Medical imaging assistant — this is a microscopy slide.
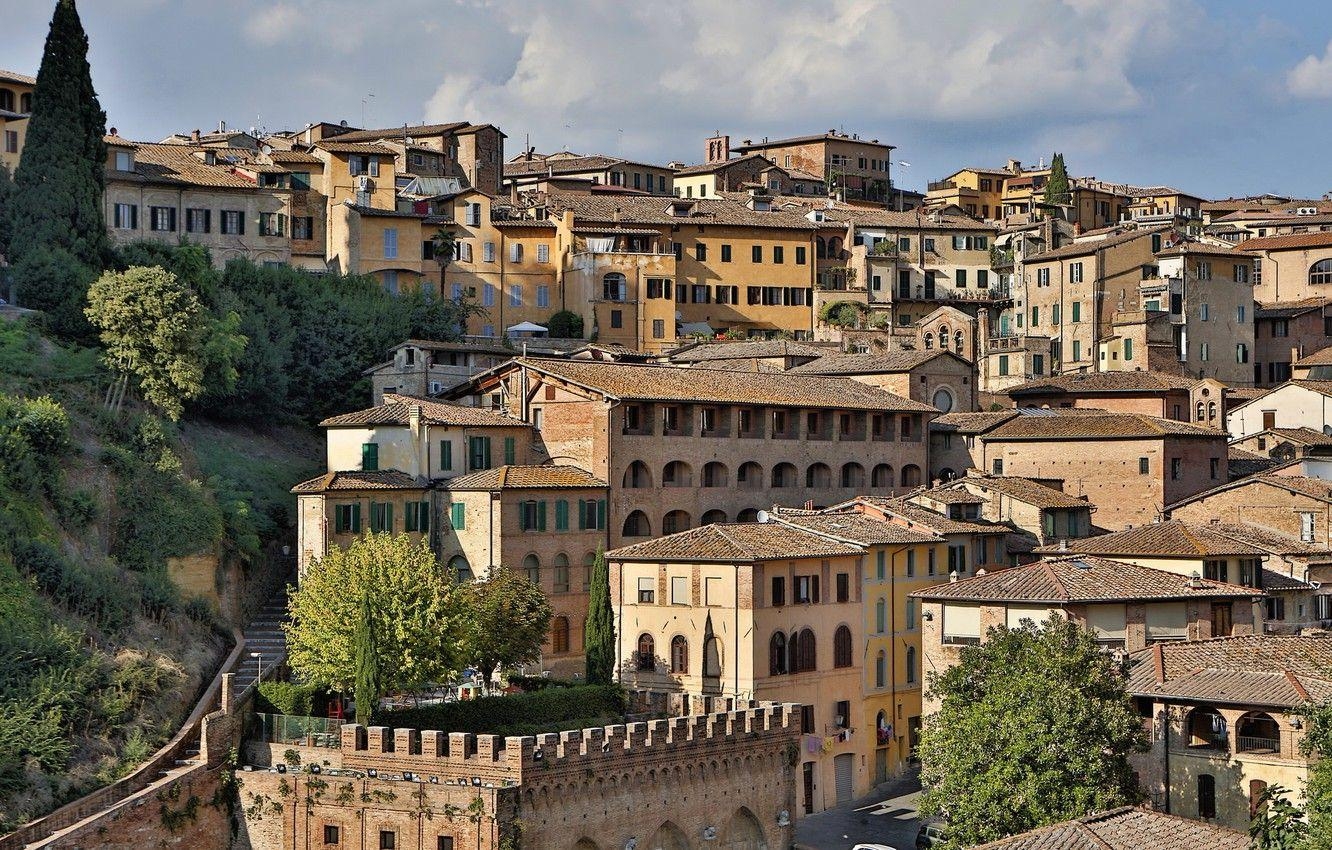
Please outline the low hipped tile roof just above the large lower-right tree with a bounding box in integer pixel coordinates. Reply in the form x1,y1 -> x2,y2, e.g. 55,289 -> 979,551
910,556 -> 1263,605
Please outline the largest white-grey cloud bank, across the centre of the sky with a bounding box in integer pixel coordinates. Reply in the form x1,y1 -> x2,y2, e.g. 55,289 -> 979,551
426,0 -> 1197,161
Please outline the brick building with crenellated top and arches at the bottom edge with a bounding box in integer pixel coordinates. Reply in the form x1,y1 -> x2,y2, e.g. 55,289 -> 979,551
236,702 -> 799,850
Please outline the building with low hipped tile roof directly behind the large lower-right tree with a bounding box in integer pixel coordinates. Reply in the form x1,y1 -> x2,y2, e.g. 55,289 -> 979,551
911,556 -> 1261,714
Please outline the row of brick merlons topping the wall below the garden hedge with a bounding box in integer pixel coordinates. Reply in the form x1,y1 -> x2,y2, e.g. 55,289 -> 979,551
341,699 -> 799,787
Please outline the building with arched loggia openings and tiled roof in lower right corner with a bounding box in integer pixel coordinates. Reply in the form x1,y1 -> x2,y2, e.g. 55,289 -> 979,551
1128,636 -> 1332,830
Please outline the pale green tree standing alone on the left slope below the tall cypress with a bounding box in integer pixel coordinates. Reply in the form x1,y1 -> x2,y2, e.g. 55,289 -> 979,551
84,266 -> 209,420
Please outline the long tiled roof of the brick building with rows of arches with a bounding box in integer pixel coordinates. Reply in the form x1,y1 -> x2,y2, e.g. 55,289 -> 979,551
496,358 -> 934,413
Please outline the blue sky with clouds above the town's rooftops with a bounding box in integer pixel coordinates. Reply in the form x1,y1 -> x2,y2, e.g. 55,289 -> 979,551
0,0 -> 1332,197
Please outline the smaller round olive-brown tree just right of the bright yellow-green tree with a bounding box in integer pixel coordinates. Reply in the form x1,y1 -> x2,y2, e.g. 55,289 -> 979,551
462,568 -> 551,687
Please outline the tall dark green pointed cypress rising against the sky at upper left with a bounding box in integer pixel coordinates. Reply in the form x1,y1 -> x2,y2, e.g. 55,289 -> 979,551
4,0 -> 107,336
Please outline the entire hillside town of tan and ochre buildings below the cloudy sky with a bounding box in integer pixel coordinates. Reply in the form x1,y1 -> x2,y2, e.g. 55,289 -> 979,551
0,0 -> 1332,850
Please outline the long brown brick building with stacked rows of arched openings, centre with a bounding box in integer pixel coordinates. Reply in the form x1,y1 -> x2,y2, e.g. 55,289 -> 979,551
452,358 -> 934,545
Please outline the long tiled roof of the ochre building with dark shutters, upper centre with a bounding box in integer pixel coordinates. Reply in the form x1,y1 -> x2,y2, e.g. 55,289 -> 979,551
550,192 -> 814,230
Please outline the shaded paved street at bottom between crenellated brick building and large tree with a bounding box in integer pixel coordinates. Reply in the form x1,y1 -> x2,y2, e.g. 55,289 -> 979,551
795,778 -> 920,850
